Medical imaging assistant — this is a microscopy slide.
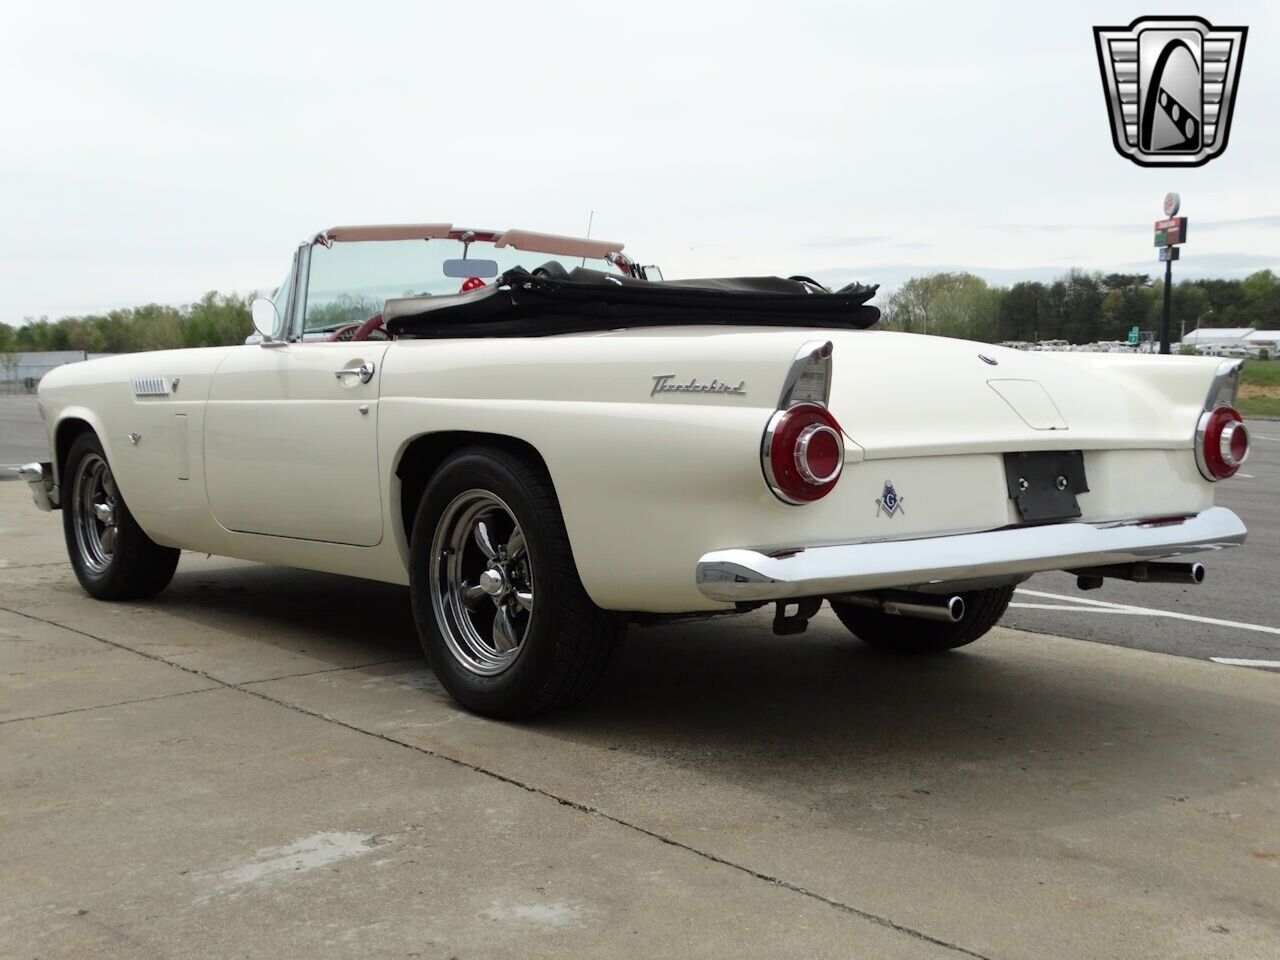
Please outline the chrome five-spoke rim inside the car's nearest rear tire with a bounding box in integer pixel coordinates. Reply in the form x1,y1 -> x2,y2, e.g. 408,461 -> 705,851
430,490 -> 534,677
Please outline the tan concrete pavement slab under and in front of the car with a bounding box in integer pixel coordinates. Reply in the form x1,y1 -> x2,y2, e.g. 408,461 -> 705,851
0,484 -> 1280,960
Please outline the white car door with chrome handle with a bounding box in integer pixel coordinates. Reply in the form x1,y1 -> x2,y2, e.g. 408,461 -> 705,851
205,340 -> 390,547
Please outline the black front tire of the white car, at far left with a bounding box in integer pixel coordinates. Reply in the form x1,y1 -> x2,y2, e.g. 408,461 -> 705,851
60,433 -> 182,600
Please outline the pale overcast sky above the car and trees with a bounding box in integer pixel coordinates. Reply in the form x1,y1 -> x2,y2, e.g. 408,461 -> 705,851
0,0 -> 1280,323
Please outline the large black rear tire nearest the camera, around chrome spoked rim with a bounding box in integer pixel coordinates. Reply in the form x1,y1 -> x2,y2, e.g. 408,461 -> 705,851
410,447 -> 626,719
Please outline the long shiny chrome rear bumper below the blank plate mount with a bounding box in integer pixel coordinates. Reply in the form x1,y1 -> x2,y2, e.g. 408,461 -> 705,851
696,507 -> 1245,602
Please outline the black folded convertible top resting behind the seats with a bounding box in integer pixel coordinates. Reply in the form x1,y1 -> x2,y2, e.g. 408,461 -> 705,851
383,268 -> 879,338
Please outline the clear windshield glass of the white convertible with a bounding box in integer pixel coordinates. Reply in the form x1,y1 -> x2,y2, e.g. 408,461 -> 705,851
303,239 -> 621,333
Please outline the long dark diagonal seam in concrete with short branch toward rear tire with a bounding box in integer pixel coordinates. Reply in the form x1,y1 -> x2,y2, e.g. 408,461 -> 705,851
0,607 -> 993,960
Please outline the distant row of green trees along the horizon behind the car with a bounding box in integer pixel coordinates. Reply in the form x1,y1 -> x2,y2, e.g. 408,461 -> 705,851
0,270 -> 1280,353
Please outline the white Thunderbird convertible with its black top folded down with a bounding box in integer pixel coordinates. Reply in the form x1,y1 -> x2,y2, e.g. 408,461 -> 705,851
22,224 -> 1248,717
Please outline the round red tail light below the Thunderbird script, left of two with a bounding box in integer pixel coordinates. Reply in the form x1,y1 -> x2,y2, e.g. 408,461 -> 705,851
760,403 -> 845,503
